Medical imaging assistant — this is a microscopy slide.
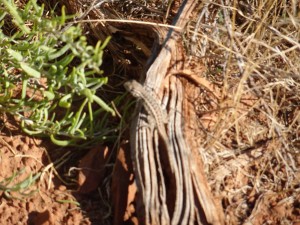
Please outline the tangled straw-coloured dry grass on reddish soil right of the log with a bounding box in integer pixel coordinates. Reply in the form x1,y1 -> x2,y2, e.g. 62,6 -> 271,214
186,1 -> 300,224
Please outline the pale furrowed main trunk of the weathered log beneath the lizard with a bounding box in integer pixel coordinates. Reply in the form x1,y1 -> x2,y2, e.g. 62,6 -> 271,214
131,0 -> 224,225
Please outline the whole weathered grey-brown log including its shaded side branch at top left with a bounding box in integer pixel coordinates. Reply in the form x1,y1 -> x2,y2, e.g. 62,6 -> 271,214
58,0 -> 225,225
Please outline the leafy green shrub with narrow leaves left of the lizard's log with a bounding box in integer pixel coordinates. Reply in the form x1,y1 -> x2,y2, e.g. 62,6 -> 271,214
0,0 -> 115,146
